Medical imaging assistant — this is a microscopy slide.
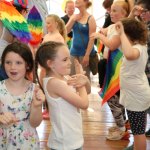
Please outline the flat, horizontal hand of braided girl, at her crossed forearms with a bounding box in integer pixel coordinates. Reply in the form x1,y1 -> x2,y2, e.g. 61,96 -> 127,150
67,74 -> 89,88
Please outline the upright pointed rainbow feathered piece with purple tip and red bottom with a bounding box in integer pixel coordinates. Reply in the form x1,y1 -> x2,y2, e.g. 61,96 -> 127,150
27,6 -> 43,45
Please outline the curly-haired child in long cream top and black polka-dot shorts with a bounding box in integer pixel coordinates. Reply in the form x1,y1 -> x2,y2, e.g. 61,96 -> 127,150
116,19 -> 150,150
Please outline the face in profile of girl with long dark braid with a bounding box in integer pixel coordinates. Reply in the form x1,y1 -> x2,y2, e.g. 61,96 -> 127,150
52,46 -> 71,75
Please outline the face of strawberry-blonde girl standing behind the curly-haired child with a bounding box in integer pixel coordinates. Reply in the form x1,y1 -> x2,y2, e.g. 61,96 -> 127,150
110,4 -> 126,23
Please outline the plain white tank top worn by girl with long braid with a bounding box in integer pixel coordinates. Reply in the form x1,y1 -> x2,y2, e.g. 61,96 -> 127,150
43,77 -> 83,150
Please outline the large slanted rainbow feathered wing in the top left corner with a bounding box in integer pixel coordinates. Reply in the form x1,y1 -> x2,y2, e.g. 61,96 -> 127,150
0,1 -> 31,43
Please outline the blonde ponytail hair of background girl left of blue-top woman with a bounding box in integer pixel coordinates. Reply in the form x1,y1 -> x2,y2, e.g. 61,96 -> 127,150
47,14 -> 67,41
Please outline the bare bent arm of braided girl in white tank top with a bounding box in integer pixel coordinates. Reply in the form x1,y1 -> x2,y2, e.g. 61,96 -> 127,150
47,78 -> 89,109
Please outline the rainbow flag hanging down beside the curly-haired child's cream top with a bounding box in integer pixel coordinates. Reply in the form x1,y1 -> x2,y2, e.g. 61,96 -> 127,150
99,49 -> 123,105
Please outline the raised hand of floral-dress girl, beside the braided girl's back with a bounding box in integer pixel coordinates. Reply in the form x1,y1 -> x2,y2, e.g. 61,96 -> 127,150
33,87 -> 45,107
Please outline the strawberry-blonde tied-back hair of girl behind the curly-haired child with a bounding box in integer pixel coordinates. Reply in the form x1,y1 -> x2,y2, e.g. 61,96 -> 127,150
113,0 -> 130,17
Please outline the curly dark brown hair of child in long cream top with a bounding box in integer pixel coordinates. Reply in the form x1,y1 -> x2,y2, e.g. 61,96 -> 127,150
121,18 -> 148,45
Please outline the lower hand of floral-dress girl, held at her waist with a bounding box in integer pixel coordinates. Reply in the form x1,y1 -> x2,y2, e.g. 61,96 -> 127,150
0,112 -> 18,125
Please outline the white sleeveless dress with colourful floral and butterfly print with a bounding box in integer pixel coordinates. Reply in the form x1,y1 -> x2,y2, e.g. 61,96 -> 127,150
0,80 -> 40,150
